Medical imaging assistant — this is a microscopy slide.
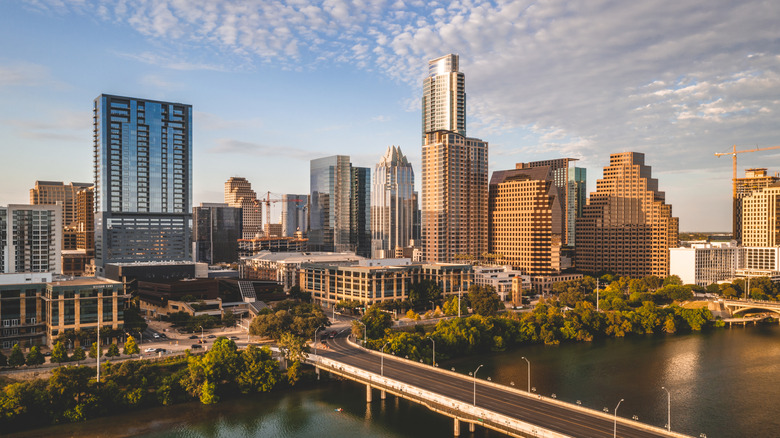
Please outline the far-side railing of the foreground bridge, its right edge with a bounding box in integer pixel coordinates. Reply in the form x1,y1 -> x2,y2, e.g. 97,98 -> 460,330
347,338 -> 690,438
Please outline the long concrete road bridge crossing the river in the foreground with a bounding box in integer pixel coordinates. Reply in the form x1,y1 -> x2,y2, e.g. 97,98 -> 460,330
306,336 -> 688,438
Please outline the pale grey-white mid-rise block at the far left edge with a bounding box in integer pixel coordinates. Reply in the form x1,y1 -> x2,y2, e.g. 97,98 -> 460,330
0,204 -> 62,274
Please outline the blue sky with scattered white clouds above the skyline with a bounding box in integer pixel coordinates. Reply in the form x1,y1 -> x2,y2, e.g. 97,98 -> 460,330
0,0 -> 780,231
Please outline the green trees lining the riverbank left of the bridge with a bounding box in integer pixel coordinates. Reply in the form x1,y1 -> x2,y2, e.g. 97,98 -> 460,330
0,337 -> 300,431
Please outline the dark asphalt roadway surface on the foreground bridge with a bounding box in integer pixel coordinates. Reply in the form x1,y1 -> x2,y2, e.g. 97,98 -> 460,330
319,337 -> 684,438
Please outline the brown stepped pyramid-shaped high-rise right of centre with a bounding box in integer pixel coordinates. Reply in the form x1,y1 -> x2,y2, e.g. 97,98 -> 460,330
576,152 -> 678,278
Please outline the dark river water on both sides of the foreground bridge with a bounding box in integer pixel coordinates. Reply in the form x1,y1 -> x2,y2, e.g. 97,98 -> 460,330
10,325 -> 780,438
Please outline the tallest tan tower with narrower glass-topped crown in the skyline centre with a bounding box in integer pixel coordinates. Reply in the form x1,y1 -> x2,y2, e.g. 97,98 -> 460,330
420,55 -> 488,262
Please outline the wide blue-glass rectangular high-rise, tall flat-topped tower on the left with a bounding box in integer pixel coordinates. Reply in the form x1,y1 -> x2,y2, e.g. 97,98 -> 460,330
93,94 -> 192,270
